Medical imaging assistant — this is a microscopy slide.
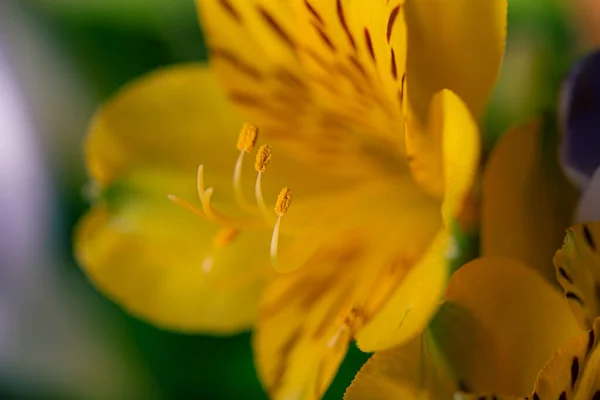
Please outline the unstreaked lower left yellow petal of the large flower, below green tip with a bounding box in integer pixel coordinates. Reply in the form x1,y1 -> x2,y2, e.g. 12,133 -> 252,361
75,170 -> 270,333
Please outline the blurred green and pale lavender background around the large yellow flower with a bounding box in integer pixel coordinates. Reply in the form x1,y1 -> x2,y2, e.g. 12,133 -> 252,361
0,0 -> 600,399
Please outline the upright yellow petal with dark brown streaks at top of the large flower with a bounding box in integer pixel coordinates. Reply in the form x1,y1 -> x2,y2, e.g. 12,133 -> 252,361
196,0 -> 406,158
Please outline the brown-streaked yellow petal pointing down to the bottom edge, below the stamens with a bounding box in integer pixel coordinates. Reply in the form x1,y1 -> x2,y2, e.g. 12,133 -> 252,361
254,180 -> 443,398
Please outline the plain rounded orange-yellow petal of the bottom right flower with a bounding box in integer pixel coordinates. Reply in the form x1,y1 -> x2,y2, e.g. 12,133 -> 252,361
446,257 -> 580,396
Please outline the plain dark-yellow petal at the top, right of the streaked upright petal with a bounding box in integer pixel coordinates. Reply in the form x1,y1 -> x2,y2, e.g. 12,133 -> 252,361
404,0 -> 507,121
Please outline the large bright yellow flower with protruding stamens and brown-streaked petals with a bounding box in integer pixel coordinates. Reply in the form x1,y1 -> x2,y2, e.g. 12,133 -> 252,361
76,0 -> 506,399
